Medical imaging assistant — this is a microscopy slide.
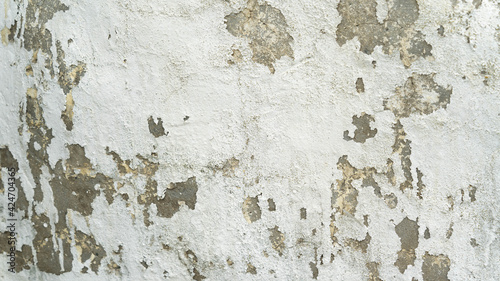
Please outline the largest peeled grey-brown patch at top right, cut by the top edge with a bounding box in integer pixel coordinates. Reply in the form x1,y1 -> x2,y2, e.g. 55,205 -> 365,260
337,0 -> 432,68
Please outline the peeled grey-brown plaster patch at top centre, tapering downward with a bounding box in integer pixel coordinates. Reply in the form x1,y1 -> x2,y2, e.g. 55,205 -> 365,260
225,0 -> 293,73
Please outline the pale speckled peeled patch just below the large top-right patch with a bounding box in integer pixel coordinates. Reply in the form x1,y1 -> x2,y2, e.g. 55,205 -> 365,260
383,73 -> 452,118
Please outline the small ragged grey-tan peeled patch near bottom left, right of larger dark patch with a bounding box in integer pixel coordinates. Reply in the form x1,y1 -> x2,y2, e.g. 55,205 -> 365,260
75,230 -> 106,274
